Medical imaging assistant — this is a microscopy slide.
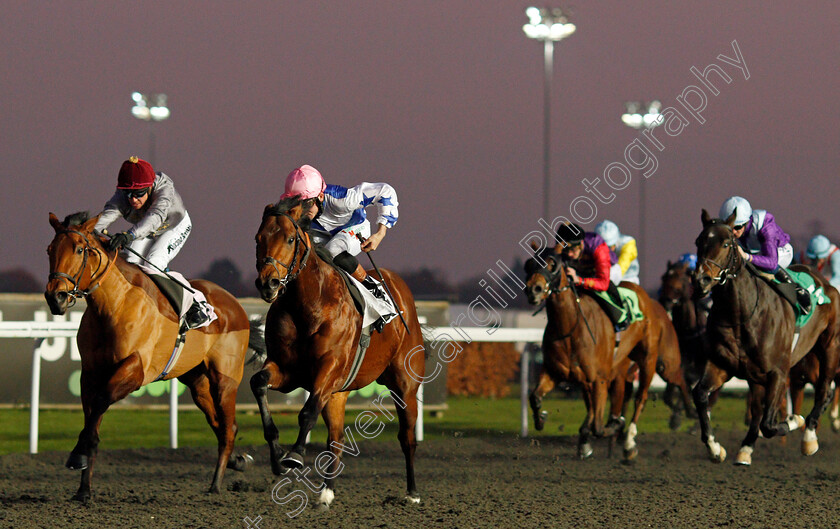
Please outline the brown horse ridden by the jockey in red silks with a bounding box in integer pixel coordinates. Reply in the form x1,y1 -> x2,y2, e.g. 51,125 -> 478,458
525,253 -> 676,459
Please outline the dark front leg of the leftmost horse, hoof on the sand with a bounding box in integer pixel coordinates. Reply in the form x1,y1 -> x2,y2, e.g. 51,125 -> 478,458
65,354 -> 143,502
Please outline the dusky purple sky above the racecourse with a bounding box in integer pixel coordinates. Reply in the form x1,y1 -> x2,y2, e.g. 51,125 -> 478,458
6,0 -> 840,286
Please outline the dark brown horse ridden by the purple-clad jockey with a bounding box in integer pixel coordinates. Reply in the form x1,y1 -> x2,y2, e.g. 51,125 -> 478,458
693,209 -> 840,465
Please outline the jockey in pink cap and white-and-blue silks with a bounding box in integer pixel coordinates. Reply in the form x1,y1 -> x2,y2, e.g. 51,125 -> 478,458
280,165 -> 399,324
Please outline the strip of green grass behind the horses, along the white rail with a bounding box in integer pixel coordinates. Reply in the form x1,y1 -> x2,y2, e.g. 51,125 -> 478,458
0,392 -> 746,455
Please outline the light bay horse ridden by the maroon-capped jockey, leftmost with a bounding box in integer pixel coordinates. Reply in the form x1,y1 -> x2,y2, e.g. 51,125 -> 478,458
44,209 -> 262,501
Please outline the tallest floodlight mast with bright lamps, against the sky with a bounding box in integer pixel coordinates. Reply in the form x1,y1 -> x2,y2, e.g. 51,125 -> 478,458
522,7 -> 576,222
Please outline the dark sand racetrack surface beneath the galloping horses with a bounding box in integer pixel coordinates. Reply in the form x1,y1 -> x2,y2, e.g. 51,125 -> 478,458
0,428 -> 840,529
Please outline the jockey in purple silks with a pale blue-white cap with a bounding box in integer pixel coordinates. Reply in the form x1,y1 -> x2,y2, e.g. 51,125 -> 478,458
720,196 -> 811,313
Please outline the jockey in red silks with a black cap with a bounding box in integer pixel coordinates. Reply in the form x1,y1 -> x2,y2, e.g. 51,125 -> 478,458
554,223 -> 630,331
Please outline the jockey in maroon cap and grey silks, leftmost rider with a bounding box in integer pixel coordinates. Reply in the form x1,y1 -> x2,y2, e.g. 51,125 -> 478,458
94,156 -> 212,329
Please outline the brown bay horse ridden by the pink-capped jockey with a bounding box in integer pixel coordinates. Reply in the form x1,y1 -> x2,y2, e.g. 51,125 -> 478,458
251,197 -> 425,507
